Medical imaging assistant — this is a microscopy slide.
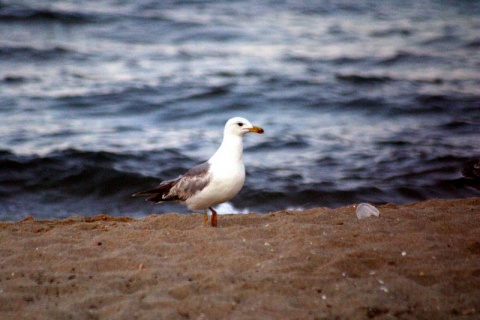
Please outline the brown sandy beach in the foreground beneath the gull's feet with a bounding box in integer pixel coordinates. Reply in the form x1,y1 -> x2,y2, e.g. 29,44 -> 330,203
0,198 -> 480,320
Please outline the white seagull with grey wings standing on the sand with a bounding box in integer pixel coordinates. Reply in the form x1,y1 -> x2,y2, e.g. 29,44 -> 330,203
132,117 -> 264,227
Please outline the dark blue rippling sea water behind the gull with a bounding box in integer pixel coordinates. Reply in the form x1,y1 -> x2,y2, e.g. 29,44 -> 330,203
0,0 -> 480,220
